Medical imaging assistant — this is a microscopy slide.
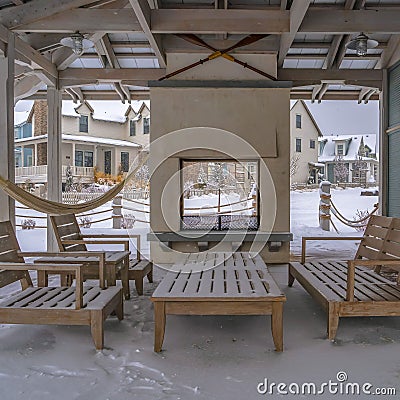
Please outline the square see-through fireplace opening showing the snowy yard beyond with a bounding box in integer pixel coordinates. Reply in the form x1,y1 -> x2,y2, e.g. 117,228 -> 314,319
180,160 -> 259,231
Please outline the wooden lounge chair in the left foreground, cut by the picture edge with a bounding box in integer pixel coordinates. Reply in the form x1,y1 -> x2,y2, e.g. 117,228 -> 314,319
0,221 -> 123,350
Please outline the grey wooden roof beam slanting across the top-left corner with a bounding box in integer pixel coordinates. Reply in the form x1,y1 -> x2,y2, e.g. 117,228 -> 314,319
0,0 -> 97,29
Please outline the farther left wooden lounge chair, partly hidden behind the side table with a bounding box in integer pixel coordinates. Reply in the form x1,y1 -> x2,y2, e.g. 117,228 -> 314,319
50,214 -> 153,299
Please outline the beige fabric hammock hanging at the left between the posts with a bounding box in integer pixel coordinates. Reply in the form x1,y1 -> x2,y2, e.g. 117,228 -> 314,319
0,155 -> 149,215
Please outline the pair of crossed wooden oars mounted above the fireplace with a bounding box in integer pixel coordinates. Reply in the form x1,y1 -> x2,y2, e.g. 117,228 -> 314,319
159,34 -> 276,81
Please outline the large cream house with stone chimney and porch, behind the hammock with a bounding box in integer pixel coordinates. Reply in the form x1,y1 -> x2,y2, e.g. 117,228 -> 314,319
15,100 -> 150,188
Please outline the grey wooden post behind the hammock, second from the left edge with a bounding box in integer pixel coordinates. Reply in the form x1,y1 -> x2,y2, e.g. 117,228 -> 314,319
47,87 -> 62,251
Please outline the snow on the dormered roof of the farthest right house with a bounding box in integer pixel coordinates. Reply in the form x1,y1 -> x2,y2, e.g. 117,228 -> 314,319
318,133 -> 378,162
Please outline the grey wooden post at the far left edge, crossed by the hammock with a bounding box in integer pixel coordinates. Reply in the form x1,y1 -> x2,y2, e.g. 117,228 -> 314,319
0,32 -> 15,225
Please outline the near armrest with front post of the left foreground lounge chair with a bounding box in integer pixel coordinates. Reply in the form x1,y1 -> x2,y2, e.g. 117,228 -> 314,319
0,262 -> 83,310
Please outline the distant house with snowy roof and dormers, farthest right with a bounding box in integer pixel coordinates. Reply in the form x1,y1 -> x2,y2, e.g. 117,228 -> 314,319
318,134 -> 379,184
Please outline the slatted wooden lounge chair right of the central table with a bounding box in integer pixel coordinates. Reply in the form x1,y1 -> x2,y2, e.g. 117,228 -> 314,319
289,216 -> 400,340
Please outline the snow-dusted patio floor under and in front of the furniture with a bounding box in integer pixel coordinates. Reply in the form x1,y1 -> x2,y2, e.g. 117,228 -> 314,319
0,265 -> 400,400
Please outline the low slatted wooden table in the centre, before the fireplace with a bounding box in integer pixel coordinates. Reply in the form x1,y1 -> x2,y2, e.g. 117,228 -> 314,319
151,253 -> 286,352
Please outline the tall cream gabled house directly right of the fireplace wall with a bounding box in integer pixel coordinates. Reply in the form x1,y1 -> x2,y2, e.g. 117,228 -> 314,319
290,100 -> 323,184
